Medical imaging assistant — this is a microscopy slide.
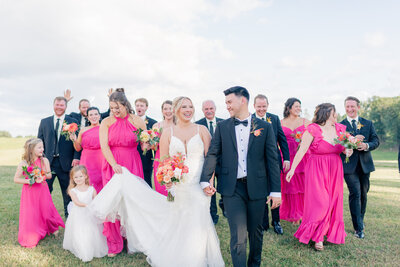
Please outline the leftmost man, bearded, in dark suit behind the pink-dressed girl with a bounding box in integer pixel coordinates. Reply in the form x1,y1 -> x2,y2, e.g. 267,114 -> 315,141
38,96 -> 80,217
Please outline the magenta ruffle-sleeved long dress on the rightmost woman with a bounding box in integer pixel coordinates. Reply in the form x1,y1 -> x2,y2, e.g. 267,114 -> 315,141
294,123 -> 346,244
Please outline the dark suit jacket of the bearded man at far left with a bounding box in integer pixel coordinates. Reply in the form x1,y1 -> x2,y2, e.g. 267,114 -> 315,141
38,115 -> 80,172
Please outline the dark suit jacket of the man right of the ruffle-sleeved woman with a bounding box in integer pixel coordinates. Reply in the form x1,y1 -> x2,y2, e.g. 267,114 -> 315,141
340,117 -> 379,174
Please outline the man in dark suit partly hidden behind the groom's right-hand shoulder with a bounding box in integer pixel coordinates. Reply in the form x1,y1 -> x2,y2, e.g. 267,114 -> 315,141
253,94 -> 290,235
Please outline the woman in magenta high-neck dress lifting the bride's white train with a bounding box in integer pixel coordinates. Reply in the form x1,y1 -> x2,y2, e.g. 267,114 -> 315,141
100,88 -> 146,257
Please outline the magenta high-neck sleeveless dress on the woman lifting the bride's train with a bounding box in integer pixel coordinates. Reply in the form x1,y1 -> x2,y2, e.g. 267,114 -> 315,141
102,114 -> 143,254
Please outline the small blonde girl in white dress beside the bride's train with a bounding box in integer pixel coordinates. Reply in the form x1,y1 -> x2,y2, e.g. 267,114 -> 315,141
63,165 -> 108,261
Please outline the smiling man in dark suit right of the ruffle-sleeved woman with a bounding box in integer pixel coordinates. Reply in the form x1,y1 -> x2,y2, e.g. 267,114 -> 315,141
341,96 -> 379,239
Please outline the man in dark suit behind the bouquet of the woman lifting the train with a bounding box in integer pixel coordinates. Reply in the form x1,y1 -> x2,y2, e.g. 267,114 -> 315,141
135,98 -> 157,187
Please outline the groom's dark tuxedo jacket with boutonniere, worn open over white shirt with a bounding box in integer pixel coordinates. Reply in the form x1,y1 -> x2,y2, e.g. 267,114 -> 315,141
200,118 -> 281,200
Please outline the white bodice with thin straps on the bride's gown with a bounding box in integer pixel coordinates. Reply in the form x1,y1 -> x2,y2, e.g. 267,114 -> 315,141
169,126 -> 204,184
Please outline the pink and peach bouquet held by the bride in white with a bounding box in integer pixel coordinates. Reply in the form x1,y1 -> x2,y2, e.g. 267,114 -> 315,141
156,153 -> 189,201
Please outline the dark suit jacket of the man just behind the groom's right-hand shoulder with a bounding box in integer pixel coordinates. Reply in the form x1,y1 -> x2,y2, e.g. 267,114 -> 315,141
253,112 -> 290,170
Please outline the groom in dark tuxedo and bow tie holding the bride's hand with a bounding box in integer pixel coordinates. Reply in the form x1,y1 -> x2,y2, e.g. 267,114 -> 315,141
200,86 -> 281,267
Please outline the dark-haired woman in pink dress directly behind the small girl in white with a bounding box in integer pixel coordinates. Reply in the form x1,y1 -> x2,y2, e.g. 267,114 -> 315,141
71,107 -> 104,193
